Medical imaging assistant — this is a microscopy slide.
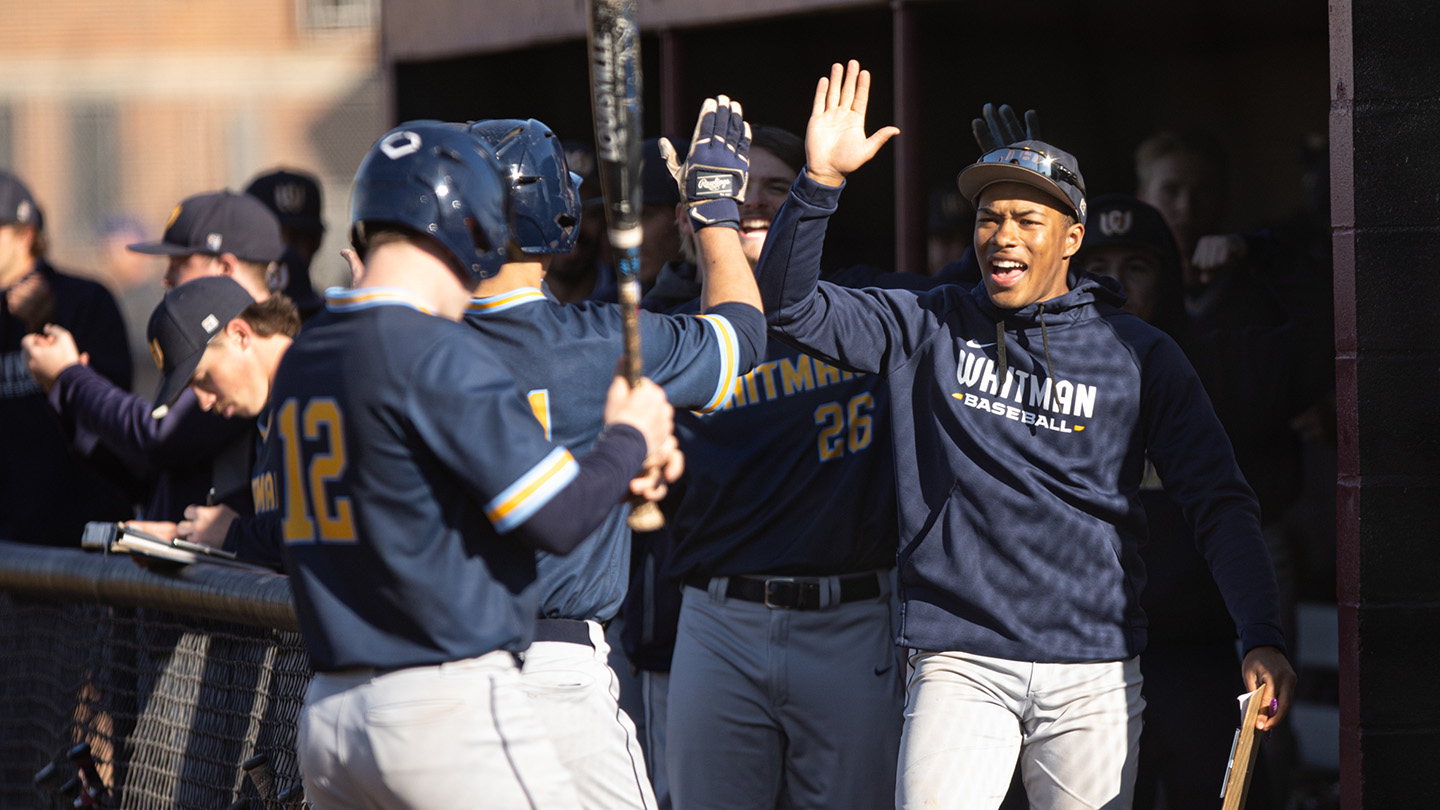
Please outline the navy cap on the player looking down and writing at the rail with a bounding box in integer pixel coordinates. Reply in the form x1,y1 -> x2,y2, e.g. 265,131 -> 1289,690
145,275 -> 255,418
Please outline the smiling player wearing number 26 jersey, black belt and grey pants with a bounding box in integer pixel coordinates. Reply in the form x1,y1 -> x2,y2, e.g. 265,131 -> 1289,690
647,121 -> 903,810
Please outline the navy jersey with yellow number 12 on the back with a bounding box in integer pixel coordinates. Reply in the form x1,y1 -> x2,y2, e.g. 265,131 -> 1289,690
268,288 -> 579,670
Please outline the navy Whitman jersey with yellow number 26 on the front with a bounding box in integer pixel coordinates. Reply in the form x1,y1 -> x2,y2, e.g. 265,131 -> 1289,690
670,268 -> 896,578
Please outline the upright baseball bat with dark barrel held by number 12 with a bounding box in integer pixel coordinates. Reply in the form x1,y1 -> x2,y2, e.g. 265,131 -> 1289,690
588,0 -> 665,532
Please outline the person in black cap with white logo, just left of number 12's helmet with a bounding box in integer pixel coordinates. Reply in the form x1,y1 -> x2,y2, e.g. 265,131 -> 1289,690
245,169 -> 325,320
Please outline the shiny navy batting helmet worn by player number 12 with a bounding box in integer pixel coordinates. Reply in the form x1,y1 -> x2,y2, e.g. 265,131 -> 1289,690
350,121 -> 511,281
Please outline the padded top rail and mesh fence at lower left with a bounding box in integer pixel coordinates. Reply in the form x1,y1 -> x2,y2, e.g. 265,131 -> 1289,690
0,540 -> 310,810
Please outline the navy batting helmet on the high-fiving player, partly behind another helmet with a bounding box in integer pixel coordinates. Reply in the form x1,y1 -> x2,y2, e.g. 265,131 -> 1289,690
469,118 -> 580,254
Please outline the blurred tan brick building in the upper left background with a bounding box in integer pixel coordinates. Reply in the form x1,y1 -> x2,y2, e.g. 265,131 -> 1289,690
0,0 -> 389,296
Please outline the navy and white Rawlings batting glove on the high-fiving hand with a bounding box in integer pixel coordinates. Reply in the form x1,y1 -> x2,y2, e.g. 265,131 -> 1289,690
660,95 -> 750,231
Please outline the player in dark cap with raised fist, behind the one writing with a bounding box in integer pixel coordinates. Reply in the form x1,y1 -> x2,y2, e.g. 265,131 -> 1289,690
29,190 -> 285,522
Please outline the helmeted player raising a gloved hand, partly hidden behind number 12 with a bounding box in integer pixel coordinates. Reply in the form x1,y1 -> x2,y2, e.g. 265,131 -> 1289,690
465,97 -> 765,810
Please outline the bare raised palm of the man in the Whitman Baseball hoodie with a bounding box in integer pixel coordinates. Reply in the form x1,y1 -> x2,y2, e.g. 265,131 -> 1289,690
805,59 -> 900,186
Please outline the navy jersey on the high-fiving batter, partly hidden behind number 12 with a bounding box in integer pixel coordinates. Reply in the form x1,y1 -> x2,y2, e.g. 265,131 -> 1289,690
465,287 -> 765,621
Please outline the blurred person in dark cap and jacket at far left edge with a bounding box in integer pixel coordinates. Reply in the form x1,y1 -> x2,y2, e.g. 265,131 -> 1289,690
0,172 -> 132,545
